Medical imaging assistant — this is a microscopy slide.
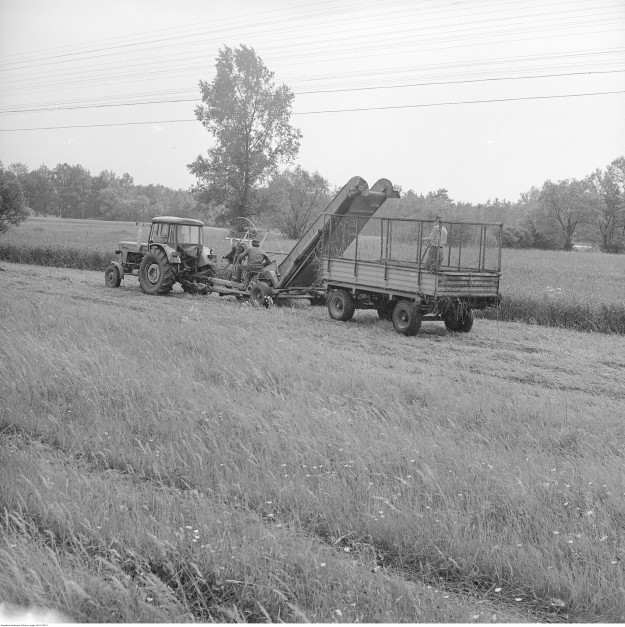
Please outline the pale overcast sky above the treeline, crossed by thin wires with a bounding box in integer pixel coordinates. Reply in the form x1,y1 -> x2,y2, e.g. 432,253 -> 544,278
0,0 -> 625,203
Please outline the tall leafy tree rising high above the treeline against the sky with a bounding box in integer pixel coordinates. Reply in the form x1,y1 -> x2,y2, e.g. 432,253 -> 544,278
187,46 -> 301,224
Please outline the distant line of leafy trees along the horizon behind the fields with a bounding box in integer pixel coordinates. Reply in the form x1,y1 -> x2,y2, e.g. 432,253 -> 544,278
0,157 -> 625,253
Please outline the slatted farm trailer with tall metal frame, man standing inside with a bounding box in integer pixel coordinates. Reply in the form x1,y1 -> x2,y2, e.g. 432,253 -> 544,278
319,214 -> 502,335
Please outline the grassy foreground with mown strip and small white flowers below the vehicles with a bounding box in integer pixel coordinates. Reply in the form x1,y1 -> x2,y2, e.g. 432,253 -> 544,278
0,266 -> 625,622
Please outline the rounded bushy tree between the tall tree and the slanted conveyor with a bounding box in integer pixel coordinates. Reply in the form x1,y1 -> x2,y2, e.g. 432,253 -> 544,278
266,165 -> 328,239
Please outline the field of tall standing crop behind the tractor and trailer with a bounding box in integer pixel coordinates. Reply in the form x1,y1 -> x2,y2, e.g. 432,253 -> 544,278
0,218 -> 625,334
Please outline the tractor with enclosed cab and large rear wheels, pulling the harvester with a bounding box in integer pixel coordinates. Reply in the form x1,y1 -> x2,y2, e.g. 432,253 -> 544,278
104,216 -> 216,295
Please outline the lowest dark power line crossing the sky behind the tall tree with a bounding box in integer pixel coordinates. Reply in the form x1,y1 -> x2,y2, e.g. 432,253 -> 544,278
0,90 -> 625,133
